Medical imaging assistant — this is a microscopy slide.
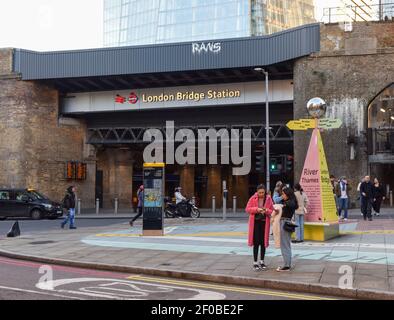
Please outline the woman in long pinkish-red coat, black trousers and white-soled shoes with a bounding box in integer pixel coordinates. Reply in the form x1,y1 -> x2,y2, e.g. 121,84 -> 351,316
246,184 -> 274,271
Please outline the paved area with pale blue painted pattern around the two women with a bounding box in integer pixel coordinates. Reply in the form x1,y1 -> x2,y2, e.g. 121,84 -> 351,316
0,209 -> 394,299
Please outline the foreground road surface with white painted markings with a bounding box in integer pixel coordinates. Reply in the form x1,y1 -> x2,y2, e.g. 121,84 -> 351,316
0,257 -> 338,301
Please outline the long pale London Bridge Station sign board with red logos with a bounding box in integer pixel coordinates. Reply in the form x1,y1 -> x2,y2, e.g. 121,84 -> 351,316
62,80 -> 293,114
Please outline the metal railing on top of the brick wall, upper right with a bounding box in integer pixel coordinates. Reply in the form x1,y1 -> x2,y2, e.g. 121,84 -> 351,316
322,2 -> 394,23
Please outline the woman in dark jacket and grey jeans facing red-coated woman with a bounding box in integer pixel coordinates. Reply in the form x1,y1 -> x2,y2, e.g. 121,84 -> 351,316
276,187 -> 298,272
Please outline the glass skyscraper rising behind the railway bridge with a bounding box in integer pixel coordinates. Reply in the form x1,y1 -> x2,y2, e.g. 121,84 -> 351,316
104,0 -> 315,47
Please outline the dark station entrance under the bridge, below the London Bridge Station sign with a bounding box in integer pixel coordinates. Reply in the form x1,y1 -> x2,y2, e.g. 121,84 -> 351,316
87,103 -> 293,208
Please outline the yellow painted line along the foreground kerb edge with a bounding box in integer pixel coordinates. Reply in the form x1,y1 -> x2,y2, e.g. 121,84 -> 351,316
127,276 -> 337,300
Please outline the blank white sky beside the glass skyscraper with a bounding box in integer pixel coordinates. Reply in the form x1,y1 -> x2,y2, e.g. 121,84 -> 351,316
0,0 -> 339,51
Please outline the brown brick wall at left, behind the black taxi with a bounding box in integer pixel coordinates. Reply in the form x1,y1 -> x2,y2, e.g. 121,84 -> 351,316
0,50 -> 96,207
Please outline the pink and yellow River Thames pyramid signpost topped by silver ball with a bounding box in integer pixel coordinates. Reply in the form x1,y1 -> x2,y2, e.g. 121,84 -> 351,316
287,98 -> 342,241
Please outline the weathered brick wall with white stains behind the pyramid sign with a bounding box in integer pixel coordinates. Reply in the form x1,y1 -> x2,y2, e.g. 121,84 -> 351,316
294,22 -> 394,204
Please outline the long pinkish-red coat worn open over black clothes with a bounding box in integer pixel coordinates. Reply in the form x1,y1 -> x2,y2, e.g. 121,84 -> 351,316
245,193 -> 274,248
